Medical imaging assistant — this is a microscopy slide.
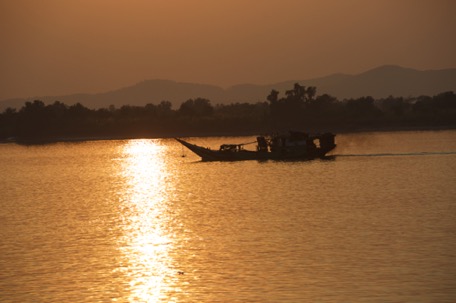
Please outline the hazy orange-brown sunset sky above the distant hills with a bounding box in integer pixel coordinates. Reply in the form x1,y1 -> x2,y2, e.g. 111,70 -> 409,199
0,0 -> 456,99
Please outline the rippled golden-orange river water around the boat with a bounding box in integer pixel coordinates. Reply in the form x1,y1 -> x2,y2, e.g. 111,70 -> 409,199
0,131 -> 456,302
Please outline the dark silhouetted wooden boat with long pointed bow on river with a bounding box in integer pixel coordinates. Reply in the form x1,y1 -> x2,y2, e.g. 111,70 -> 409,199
176,132 -> 336,161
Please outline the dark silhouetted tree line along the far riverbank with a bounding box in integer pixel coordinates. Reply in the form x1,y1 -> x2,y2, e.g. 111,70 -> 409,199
0,83 -> 456,142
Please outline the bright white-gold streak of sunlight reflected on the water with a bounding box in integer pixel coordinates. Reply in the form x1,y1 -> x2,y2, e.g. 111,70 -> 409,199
120,140 -> 176,302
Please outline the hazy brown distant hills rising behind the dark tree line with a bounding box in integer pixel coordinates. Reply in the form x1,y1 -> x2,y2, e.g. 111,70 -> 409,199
0,65 -> 456,112
